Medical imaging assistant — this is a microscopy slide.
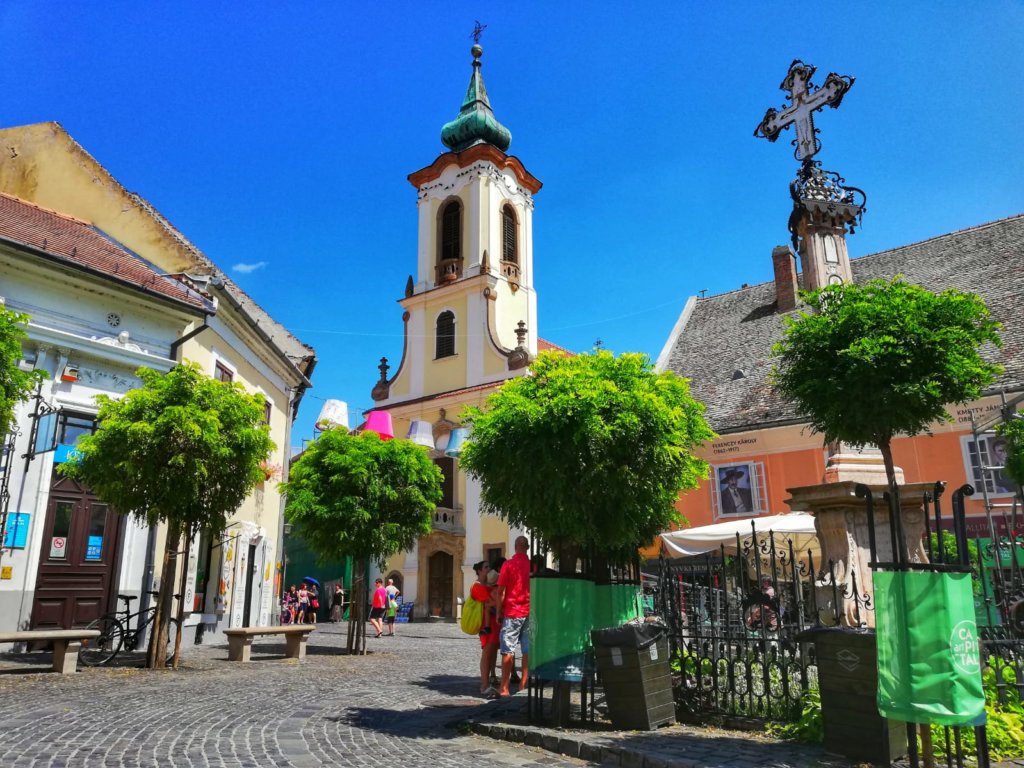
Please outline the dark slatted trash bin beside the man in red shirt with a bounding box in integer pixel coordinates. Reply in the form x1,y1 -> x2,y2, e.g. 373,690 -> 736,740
590,623 -> 676,730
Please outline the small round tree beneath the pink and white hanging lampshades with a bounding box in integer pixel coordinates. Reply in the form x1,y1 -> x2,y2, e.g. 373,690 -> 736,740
282,429 -> 442,653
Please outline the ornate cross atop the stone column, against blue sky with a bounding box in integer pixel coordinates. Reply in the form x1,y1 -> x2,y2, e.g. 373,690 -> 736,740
754,58 -> 854,161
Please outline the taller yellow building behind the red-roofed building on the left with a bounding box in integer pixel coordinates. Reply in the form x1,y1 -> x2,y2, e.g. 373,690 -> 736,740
0,123 -> 316,632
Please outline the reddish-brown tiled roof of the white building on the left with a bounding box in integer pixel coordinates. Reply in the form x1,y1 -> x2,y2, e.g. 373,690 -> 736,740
0,193 -> 213,311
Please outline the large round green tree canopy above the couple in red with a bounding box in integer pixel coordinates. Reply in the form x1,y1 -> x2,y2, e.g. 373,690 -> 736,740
460,350 -> 715,556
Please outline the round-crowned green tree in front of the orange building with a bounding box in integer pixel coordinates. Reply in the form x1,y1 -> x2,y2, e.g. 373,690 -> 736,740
772,276 -> 1001,484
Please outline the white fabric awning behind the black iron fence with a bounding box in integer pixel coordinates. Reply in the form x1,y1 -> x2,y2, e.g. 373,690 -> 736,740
662,512 -> 819,559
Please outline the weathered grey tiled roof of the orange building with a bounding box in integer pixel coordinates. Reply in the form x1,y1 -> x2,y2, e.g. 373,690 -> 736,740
658,215 -> 1024,433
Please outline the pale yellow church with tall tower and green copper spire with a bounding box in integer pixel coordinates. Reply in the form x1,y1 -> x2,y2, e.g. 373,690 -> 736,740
373,45 -> 551,617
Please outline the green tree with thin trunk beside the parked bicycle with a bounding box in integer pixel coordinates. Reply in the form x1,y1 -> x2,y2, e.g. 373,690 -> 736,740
61,364 -> 274,668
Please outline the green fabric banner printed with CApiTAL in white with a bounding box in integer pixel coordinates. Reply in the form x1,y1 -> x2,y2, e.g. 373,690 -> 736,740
873,571 -> 985,725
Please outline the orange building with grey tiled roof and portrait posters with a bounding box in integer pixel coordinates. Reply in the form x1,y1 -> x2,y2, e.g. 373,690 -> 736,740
657,210 -> 1024,535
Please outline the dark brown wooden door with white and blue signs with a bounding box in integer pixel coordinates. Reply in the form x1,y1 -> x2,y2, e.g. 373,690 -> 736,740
32,477 -> 122,629
